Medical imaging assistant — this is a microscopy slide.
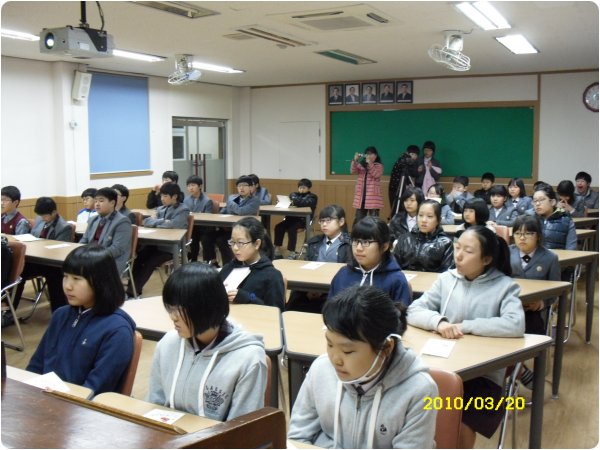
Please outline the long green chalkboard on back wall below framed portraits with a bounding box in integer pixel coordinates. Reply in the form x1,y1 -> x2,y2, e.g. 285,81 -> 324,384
329,106 -> 534,179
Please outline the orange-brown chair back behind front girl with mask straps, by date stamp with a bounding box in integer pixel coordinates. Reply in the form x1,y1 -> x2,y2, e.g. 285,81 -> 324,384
429,368 -> 463,448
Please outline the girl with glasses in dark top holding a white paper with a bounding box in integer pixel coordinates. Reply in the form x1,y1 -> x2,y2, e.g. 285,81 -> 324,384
219,217 -> 285,311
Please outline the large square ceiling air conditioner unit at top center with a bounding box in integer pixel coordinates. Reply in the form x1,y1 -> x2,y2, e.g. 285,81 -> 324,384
269,4 -> 393,31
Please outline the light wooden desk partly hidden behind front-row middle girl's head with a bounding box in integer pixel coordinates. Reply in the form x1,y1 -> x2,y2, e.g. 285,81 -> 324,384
122,296 -> 283,407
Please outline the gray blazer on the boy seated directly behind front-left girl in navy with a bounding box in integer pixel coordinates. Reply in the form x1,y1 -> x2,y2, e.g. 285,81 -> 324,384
79,211 -> 131,273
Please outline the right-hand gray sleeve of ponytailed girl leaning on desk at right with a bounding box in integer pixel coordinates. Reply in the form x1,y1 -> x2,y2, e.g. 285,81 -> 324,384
461,280 -> 525,337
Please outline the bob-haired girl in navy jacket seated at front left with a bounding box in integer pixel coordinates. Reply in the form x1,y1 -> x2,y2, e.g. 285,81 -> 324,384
27,244 -> 135,395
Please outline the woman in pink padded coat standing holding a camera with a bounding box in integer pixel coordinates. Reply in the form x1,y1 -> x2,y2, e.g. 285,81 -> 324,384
350,147 -> 383,223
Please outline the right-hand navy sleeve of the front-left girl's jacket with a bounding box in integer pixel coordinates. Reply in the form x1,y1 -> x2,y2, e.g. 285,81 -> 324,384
83,326 -> 133,394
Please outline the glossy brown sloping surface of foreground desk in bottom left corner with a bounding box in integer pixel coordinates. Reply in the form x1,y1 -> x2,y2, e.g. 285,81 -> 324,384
2,379 -> 218,448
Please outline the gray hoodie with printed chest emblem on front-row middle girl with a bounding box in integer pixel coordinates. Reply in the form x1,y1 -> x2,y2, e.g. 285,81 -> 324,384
148,325 -> 267,421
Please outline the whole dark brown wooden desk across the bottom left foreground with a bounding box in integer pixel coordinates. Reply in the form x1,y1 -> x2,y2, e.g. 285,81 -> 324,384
2,379 -> 285,449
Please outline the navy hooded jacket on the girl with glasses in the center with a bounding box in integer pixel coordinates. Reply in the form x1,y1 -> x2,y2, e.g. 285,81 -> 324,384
329,255 -> 412,307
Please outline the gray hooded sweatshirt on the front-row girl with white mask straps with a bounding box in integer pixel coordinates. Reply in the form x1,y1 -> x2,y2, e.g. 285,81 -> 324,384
288,341 -> 438,448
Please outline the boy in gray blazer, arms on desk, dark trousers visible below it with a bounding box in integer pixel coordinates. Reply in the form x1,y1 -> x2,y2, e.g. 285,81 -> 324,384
127,183 -> 190,297
